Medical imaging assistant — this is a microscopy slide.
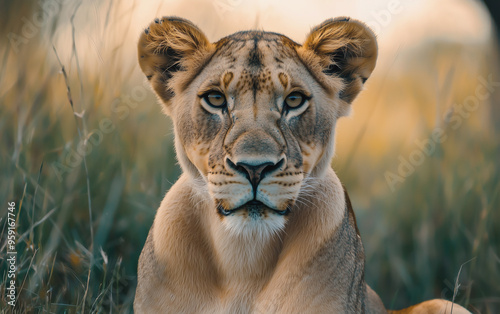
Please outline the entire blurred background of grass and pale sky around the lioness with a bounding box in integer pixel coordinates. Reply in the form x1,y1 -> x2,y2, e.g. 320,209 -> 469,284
0,0 -> 500,313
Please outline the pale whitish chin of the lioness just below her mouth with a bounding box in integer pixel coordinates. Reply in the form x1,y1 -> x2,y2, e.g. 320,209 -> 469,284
217,201 -> 290,239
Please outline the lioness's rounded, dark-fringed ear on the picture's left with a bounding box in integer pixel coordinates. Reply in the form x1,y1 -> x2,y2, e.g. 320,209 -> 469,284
138,17 -> 211,105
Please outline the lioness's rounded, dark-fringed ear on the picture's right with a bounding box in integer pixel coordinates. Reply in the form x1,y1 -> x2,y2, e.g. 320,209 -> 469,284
303,17 -> 378,103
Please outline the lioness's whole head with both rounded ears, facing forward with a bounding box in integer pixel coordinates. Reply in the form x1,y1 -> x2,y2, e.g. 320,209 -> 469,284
139,18 -> 377,232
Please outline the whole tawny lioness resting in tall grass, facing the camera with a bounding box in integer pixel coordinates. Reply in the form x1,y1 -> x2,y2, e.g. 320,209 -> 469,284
134,17 -> 467,313
